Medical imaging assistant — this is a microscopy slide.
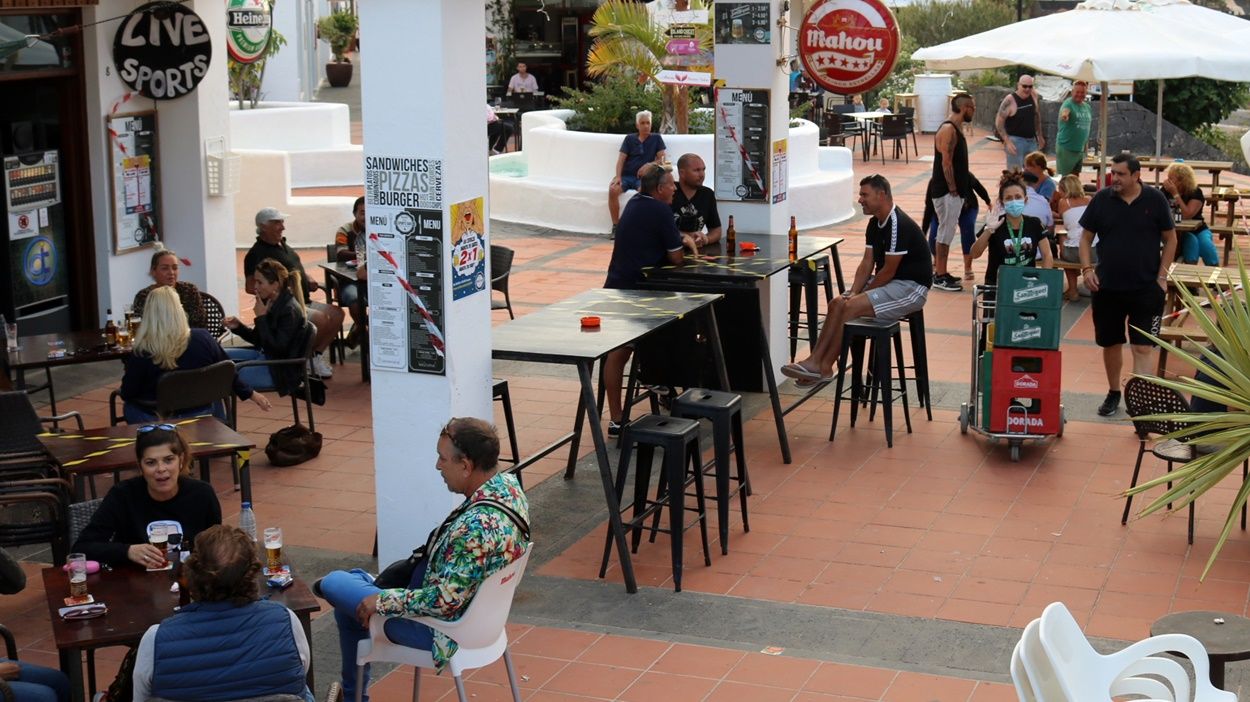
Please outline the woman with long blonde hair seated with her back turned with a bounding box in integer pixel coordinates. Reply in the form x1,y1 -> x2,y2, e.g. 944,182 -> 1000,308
120,287 -> 269,425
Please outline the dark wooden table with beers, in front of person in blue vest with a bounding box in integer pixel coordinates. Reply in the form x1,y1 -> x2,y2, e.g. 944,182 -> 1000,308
43,566 -> 321,702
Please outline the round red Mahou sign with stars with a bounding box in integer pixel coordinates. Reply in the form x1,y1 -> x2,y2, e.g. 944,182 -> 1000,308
799,0 -> 899,95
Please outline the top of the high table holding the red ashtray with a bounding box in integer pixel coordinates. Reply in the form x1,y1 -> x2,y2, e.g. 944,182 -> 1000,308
491,289 -> 721,363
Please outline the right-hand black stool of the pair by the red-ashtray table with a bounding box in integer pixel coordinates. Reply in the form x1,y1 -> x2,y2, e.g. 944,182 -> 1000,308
673,387 -> 751,555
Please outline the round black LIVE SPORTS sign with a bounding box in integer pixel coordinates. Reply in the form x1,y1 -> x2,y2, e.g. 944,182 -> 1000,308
113,1 -> 213,100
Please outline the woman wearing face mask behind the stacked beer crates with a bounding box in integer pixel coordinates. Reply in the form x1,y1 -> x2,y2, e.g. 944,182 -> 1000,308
971,172 -> 1055,292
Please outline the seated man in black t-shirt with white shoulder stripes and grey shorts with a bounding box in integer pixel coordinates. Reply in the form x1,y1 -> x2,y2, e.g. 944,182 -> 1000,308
781,175 -> 934,387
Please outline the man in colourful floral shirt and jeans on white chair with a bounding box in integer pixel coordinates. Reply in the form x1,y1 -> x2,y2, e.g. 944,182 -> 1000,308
314,417 -> 530,700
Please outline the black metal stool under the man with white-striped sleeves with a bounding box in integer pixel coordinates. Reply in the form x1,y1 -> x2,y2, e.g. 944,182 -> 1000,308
829,317 -> 911,447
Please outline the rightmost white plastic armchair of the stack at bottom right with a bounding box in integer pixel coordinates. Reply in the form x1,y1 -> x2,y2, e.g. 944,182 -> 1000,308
1021,602 -> 1238,702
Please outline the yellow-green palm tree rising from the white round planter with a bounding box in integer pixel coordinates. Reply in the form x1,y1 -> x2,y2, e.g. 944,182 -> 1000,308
586,0 -> 713,134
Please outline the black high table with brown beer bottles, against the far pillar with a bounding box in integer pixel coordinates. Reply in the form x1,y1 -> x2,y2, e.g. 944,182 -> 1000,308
643,234 -> 845,463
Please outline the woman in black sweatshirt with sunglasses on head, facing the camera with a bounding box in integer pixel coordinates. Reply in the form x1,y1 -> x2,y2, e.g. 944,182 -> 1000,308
73,425 -> 221,568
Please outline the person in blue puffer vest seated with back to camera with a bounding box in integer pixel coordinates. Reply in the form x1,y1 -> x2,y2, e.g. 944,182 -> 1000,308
134,525 -> 314,702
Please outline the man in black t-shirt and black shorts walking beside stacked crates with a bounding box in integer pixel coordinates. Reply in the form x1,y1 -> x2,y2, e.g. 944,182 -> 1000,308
1081,154 -> 1176,417
